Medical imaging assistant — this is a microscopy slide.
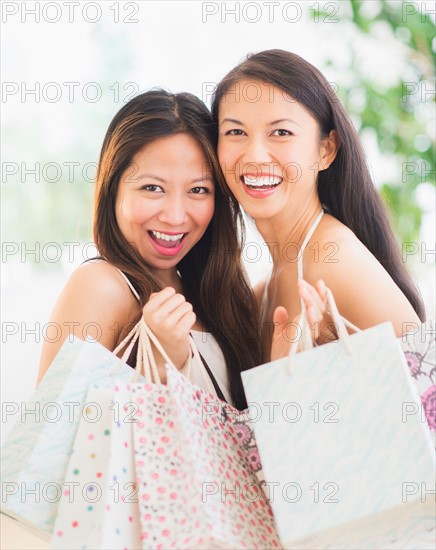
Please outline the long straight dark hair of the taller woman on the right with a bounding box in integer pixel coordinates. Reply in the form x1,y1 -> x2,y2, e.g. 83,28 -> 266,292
212,50 -> 425,321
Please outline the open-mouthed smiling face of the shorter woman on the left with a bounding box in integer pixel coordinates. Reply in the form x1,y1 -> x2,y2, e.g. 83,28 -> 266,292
115,134 -> 215,271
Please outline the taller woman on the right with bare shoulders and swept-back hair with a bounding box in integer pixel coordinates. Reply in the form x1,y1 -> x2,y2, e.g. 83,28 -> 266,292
212,50 -> 425,360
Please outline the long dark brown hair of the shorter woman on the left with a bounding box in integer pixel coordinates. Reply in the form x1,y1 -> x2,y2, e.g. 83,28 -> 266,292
94,90 -> 261,409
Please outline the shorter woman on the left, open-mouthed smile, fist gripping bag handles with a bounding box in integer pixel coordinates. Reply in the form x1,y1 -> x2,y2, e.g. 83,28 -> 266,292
39,90 -> 260,409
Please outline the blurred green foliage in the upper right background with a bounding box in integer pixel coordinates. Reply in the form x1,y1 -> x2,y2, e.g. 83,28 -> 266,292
314,0 -> 435,242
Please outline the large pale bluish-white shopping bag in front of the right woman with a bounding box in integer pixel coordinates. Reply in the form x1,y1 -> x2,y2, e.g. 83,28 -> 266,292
242,291 -> 435,549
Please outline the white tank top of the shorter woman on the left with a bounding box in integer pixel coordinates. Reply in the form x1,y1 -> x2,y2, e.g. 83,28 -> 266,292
117,268 -> 233,404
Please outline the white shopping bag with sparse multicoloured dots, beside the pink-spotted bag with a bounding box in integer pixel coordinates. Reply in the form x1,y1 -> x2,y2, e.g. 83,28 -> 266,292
51,380 -> 141,550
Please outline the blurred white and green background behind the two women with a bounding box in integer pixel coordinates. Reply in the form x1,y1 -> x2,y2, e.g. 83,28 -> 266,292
1,0 -> 435,436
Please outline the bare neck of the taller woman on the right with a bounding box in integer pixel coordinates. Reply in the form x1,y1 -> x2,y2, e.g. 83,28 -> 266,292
256,196 -> 322,269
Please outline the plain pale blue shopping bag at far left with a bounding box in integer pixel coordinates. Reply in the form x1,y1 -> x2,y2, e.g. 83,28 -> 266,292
1,338 -> 142,538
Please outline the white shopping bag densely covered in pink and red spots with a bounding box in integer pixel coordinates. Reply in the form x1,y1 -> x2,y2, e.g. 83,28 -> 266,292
127,322 -> 280,549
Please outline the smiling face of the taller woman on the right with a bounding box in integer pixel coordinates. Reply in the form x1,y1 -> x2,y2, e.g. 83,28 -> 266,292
218,80 -> 336,220
